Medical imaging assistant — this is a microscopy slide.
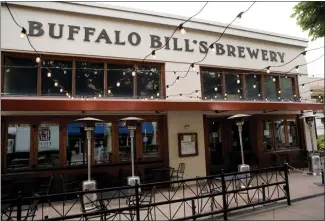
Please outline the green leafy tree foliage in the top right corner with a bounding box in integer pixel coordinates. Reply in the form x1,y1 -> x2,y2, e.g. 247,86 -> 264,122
291,1 -> 325,41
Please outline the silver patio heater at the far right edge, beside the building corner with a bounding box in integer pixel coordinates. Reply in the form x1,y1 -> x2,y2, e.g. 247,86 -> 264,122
300,114 -> 321,176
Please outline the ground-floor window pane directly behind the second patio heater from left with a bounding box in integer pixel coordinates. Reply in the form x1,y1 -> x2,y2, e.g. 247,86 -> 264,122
118,122 -> 137,162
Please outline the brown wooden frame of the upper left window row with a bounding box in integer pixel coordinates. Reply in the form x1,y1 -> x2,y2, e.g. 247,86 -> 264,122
1,51 -> 166,98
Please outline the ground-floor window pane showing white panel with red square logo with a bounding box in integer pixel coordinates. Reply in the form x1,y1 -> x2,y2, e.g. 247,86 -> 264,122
37,124 -> 60,168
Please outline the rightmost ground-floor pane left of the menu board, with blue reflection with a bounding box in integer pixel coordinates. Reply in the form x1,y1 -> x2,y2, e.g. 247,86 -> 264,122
141,122 -> 160,160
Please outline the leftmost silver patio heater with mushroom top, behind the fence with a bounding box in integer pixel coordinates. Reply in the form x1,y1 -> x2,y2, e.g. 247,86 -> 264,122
75,117 -> 102,210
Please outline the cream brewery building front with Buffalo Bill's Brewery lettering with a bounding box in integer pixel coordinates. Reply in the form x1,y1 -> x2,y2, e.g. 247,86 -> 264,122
1,2 -> 323,181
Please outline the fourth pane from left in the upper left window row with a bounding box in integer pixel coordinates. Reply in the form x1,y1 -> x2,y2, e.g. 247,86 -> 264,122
107,64 -> 133,97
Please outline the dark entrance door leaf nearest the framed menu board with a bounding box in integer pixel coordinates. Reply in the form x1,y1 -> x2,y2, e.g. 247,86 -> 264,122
207,119 -> 225,175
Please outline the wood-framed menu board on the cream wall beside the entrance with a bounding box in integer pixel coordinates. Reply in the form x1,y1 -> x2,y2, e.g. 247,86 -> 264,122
178,133 -> 199,157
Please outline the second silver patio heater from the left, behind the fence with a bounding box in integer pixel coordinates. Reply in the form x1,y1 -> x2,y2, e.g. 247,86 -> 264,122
121,117 -> 143,191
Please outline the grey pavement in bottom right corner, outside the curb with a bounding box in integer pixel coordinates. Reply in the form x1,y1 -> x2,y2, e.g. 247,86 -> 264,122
228,196 -> 325,220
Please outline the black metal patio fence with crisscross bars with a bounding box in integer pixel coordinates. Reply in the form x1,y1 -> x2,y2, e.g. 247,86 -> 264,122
1,164 -> 290,221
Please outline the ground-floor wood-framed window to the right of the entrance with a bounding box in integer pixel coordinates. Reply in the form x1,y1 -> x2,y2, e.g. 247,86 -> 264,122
262,118 -> 298,151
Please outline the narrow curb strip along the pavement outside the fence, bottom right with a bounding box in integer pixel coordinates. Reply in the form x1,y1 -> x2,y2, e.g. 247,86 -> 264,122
207,193 -> 325,221
